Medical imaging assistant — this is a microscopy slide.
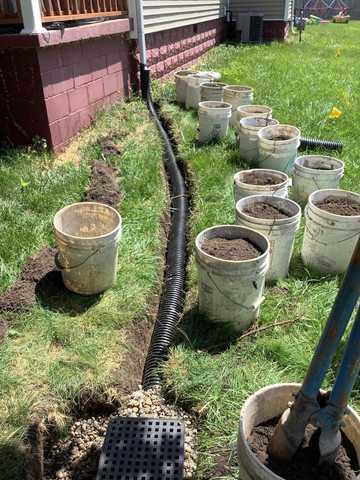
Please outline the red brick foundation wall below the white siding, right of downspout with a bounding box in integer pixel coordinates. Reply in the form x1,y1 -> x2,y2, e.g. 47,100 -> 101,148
146,19 -> 225,78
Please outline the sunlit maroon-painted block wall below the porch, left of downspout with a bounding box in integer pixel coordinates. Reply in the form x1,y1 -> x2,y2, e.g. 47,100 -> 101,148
38,36 -> 131,150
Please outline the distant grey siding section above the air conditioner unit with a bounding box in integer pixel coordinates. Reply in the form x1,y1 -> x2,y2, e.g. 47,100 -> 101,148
230,0 -> 287,20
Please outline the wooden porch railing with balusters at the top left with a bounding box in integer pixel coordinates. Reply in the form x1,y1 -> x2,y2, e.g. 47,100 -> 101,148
0,0 -> 128,25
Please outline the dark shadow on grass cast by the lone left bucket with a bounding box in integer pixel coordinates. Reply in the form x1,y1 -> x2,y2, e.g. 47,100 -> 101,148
35,270 -> 101,317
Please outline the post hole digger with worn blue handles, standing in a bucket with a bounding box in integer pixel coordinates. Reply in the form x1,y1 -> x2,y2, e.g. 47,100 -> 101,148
269,238 -> 360,463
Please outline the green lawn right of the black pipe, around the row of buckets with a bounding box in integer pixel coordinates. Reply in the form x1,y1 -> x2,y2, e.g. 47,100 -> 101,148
158,22 -> 360,479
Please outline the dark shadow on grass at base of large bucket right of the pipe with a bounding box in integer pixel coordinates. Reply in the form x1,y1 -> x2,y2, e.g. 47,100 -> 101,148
175,306 -> 239,355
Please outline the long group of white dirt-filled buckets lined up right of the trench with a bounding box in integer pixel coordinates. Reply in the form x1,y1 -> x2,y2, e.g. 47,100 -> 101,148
176,71 -> 360,332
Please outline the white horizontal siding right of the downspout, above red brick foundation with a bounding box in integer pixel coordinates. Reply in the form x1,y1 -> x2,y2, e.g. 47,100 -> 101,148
141,0 -> 225,33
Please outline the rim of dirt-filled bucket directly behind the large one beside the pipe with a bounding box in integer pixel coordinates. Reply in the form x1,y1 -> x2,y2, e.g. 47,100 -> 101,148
235,194 -> 302,227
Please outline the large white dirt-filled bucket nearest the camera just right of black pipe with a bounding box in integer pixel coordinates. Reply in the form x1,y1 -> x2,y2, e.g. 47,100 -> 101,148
195,225 -> 269,332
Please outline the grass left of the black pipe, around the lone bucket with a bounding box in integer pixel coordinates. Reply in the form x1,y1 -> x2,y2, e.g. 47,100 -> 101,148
0,101 -> 167,480
